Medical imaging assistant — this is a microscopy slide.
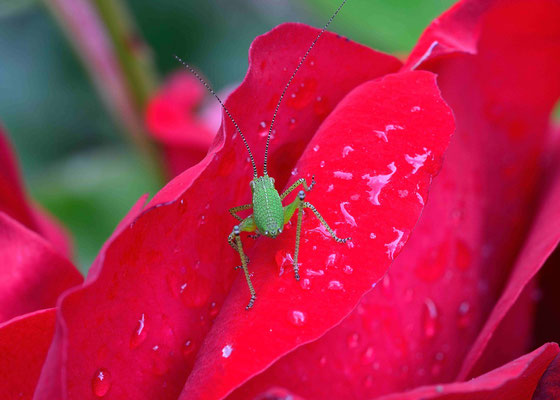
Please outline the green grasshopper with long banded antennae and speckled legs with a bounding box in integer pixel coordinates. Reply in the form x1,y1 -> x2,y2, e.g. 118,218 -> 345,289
175,0 -> 351,310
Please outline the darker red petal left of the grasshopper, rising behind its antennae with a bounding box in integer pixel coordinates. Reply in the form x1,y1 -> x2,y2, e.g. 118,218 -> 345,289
36,24 -> 402,399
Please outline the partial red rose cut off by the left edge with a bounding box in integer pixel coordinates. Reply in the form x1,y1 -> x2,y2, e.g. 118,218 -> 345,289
0,126 -> 83,399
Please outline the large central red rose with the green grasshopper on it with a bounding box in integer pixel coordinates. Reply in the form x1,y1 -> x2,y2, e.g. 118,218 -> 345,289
0,0 -> 560,399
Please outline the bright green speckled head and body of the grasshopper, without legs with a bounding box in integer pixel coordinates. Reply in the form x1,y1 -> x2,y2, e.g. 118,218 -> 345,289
250,175 -> 284,238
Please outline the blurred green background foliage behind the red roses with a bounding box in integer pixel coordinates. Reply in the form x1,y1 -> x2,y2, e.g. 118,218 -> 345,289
0,0 -> 452,271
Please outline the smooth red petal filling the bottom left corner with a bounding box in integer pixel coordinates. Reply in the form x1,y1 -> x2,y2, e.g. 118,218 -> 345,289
0,308 -> 55,399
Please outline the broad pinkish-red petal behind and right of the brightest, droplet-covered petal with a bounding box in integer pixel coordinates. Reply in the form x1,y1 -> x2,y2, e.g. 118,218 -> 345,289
232,1 -> 560,398
